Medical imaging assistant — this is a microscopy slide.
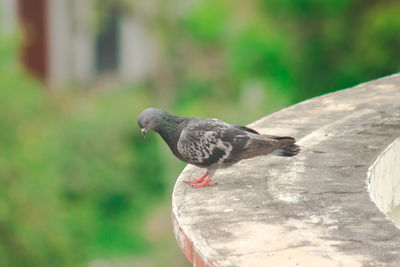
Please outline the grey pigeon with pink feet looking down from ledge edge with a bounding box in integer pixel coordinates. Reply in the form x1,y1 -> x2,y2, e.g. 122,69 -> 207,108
138,108 -> 300,188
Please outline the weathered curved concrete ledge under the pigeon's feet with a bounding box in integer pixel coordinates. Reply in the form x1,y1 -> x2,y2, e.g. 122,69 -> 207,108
172,74 -> 400,266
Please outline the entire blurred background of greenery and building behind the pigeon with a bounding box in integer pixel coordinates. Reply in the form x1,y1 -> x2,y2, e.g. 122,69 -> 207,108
0,0 -> 400,267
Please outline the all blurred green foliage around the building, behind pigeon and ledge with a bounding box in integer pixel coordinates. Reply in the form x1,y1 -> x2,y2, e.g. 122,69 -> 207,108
0,0 -> 400,266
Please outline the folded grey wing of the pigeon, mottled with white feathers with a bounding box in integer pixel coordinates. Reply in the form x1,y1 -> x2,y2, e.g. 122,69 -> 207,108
177,119 -> 279,166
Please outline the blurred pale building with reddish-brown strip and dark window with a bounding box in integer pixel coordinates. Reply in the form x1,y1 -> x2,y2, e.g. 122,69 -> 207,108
0,0 -> 157,89
